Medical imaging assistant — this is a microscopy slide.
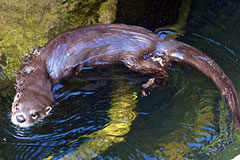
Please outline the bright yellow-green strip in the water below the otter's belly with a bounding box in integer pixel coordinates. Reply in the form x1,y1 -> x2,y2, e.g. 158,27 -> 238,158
55,78 -> 137,159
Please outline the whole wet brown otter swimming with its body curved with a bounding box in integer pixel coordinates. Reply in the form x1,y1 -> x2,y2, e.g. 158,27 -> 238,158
11,24 -> 240,128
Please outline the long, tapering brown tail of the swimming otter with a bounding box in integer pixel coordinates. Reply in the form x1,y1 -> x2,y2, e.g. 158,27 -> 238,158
157,39 -> 240,129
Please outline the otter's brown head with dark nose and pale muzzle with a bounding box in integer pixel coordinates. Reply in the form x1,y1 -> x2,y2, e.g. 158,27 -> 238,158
11,92 -> 52,127
